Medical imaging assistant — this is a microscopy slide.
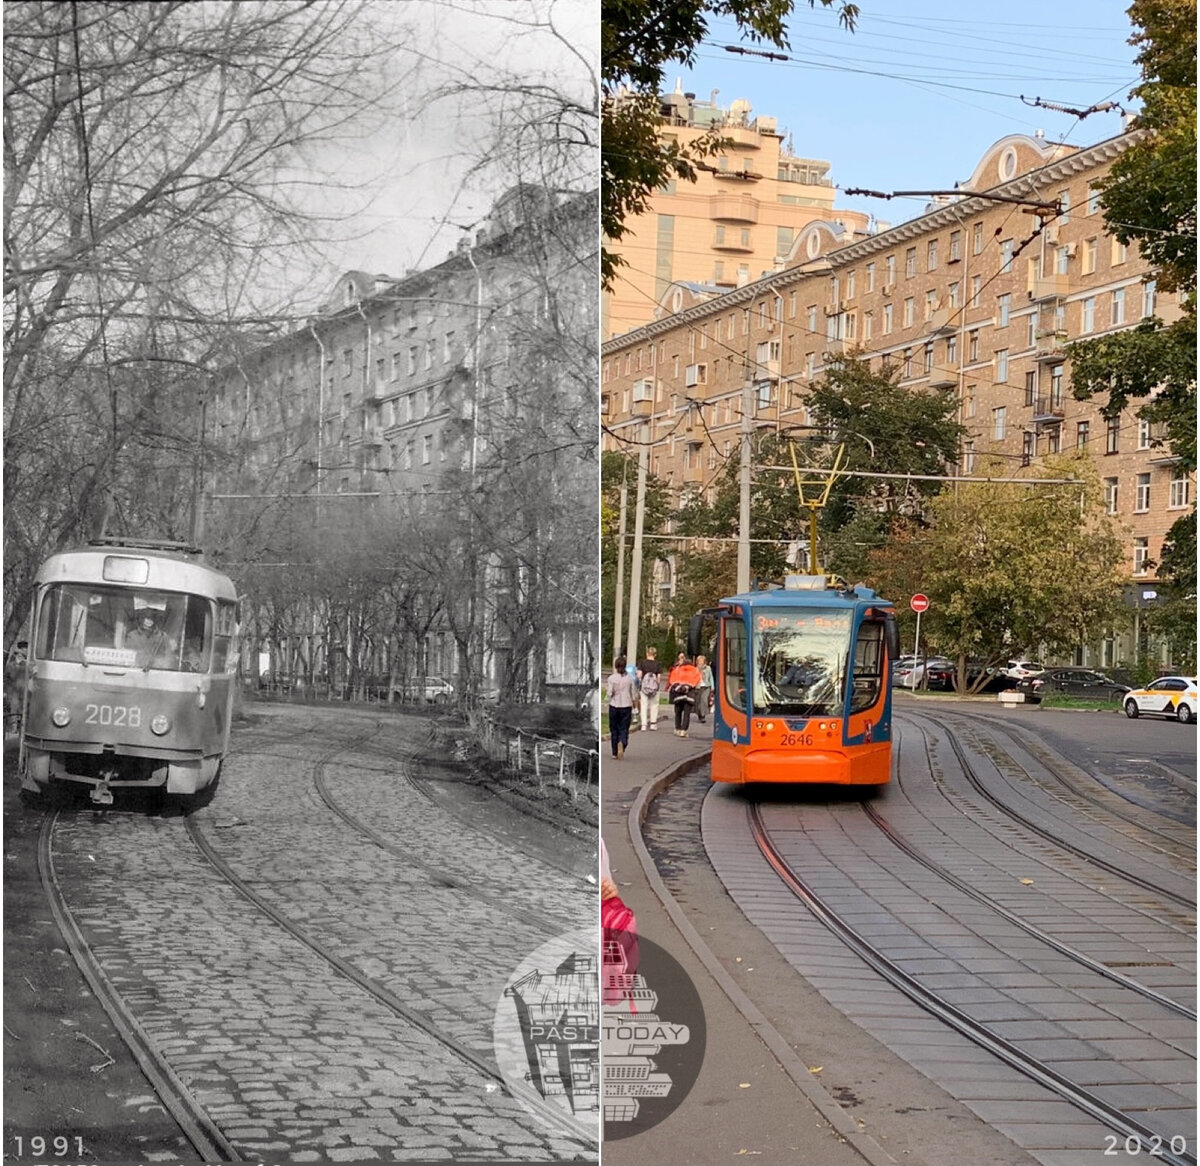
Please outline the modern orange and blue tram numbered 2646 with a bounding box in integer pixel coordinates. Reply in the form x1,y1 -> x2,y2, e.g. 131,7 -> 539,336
688,575 -> 899,787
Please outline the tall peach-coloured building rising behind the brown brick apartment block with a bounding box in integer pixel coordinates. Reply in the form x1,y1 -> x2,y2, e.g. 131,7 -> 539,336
601,89 -> 869,337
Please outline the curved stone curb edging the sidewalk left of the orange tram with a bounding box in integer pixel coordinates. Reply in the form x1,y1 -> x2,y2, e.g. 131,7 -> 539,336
628,753 -> 896,1166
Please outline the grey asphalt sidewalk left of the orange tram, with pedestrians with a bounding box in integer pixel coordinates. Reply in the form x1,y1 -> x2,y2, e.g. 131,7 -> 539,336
600,707 -> 892,1166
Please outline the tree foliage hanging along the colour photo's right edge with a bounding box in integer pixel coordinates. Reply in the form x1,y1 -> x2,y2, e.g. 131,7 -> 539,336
1067,0 -> 1196,660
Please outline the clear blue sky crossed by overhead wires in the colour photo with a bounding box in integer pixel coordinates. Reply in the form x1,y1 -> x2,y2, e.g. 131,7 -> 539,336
666,0 -> 1139,232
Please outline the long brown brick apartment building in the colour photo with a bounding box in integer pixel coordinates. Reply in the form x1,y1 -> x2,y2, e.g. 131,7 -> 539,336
601,134 -> 1194,665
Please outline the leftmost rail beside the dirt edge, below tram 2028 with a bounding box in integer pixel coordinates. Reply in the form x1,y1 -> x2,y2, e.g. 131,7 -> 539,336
37,810 -> 241,1162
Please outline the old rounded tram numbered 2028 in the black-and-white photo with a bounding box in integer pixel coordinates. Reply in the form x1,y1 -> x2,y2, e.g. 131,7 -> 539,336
20,539 -> 239,805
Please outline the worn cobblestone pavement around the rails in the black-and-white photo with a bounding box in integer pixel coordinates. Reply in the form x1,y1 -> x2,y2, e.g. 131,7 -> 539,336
46,709 -> 595,1161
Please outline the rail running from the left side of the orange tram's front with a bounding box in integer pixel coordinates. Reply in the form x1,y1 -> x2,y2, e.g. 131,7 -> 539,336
746,803 -> 1196,1166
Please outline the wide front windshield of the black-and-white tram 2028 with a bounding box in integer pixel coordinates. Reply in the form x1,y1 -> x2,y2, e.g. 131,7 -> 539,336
36,583 -> 214,672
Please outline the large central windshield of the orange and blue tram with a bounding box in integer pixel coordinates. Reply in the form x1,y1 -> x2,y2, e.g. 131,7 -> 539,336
752,608 -> 851,716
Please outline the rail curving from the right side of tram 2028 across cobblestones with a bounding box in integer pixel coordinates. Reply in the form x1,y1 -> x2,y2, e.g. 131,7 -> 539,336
178,816 -> 584,1143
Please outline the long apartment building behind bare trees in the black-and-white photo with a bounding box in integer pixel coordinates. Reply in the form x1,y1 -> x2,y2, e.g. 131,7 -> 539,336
209,185 -> 599,691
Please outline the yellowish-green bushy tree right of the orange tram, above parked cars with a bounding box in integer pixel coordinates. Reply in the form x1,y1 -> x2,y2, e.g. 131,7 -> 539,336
868,455 -> 1124,692
